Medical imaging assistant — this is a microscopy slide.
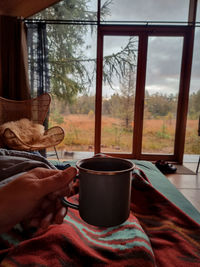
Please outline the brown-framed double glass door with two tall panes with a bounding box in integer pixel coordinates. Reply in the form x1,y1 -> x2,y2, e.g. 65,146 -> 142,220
95,26 -> 192,162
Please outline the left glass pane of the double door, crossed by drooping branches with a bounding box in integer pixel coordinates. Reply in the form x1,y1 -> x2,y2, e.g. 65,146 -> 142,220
101,36 -> 138,153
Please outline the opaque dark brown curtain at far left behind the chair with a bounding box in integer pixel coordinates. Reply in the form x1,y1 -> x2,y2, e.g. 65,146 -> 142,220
0,16 -> 30,100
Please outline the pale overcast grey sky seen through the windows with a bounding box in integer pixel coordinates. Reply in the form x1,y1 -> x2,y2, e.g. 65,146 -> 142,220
98,0 -> 200,94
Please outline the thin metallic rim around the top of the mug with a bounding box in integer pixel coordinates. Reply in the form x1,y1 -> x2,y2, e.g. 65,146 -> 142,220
76,157 -> 136,175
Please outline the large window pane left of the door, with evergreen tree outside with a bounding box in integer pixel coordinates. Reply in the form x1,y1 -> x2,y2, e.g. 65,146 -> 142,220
29,24 -> 96,159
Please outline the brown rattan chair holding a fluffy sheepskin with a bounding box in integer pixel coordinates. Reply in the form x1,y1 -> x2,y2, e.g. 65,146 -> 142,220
0,93 -> 64,159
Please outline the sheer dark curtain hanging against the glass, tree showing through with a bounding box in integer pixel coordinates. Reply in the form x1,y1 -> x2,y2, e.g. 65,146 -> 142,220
26,22 -> 50,96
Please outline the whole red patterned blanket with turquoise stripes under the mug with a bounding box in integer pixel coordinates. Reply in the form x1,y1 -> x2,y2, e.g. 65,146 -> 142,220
0,170 -> 200,267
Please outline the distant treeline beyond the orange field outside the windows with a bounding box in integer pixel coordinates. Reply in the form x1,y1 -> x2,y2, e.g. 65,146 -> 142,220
52,90 -> 200,121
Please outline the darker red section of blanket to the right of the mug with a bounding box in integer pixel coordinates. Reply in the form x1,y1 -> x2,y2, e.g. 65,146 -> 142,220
132,172 -> 200,267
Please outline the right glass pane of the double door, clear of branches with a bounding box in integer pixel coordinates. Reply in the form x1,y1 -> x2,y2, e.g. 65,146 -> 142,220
142,37 -> 183,154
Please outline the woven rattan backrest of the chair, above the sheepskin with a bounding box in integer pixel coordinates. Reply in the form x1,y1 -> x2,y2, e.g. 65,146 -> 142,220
0,93 -> 51,125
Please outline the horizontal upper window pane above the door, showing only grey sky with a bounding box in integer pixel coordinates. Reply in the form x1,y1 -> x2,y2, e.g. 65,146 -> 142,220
102,0 -> 189,22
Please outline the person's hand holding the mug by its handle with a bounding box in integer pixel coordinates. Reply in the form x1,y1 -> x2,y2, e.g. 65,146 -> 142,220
0,167 -> 77,232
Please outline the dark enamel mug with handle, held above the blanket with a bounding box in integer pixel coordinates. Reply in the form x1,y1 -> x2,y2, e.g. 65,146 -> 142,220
62,157 -> 135,227
